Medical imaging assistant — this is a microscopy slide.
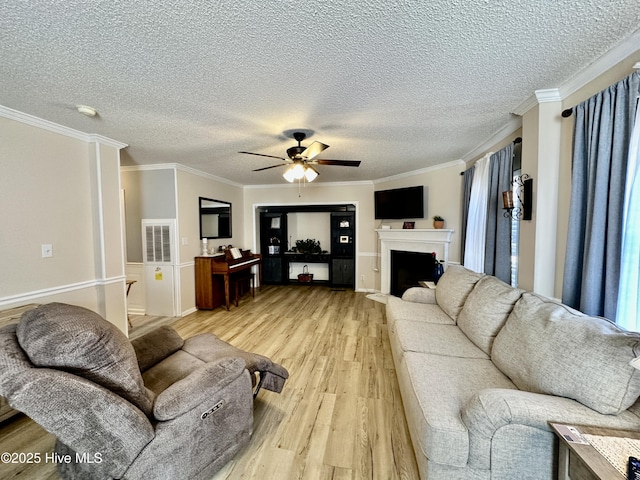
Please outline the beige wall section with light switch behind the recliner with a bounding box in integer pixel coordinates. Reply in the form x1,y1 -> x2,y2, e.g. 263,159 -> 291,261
0,107 -> 127,331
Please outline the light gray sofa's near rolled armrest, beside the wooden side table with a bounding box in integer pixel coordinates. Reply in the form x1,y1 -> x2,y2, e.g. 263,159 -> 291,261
462,388 -> 640,469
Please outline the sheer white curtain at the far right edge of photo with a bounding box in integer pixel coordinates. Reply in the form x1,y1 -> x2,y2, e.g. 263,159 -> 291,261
616,100 -> 640,331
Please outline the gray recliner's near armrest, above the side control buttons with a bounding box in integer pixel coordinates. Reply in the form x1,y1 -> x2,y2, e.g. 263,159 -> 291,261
153,358 -> 251,421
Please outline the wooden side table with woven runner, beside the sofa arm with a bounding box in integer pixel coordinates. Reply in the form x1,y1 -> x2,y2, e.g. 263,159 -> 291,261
550,423 -> 640,480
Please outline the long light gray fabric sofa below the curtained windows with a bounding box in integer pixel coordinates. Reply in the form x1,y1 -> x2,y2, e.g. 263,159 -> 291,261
386,265 -> 640,480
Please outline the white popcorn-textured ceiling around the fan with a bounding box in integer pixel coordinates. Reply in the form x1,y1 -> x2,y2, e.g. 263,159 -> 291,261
0,0 -> 640,185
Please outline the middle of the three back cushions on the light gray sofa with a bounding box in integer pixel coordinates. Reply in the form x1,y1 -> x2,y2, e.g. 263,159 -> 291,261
458,276 -> 524,354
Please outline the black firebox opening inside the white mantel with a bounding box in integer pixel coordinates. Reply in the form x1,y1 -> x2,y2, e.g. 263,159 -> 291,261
389,250 -> 437,297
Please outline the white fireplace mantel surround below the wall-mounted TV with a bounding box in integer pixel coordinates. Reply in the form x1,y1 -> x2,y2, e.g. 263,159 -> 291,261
376,228 -> 454,294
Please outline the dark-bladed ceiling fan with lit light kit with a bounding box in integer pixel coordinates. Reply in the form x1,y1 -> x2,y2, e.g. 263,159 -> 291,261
238,132 -> 360,182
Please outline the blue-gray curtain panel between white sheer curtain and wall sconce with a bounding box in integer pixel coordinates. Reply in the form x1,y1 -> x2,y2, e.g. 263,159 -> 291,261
484,143 -> 513,283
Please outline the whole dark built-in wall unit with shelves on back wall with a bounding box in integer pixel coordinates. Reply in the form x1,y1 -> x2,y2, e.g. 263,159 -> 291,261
260,205 -> 356,288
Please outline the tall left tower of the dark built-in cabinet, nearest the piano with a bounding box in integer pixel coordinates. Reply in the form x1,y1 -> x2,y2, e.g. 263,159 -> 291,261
260,212 -> 288,285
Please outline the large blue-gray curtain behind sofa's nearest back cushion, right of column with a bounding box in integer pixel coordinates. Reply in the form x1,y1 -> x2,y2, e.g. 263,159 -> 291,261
564,73 -> 640,320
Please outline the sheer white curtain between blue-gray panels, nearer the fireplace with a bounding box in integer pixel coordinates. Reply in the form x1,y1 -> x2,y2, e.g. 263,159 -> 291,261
464,153 -> 493,273
